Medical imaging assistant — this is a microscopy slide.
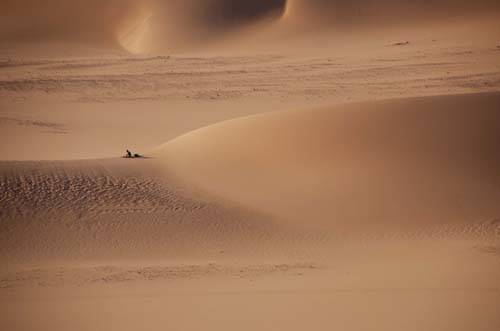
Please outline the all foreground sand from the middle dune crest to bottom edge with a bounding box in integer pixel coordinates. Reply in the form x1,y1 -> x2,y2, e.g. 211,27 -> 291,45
0,89 -> 500,331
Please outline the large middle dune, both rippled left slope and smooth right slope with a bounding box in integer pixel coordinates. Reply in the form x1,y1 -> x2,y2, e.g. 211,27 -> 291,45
0,93 -> 500,263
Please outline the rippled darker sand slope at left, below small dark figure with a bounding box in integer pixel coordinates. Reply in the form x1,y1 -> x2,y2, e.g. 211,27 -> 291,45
0,159 -> 286,266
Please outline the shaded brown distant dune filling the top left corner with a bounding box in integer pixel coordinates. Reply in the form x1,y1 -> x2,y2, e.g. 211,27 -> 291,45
0,0 -> 145,45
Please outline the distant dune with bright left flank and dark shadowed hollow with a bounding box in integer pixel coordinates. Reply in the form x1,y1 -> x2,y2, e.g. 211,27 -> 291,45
139,0 -> 286,51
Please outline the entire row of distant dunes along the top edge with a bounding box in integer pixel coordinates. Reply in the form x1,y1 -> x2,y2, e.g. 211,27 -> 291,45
0,0 -> 500,51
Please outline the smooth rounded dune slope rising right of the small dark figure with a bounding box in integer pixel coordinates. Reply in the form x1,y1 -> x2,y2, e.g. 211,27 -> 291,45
158,93 -> 500,236
